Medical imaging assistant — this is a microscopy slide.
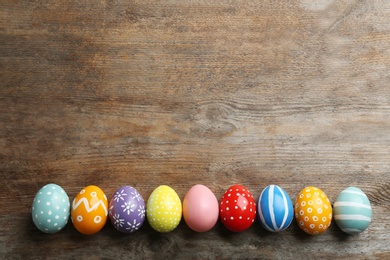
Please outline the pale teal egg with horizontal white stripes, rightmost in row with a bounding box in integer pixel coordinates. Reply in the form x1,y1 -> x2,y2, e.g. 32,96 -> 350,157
333,187 -> 372,234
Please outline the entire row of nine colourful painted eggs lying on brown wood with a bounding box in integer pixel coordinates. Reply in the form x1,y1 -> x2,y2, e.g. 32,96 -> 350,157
32,184 -> 372,235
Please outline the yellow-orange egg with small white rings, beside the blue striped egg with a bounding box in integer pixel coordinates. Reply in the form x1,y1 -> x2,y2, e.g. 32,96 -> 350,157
294,186 -> 332,235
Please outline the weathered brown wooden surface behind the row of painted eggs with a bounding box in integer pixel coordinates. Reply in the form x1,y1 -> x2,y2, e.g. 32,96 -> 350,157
0,0 -> 390,259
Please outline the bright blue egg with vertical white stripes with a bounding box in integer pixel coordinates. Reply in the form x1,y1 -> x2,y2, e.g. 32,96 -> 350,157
257,185 -> 294,232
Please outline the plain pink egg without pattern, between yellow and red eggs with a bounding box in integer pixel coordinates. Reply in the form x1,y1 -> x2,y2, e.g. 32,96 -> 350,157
183,184 -> 219,232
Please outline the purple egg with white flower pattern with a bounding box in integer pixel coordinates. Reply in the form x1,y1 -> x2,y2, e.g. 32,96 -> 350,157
108,186 -> 145,234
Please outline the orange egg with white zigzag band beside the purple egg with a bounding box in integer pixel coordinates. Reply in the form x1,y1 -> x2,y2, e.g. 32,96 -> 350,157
71,185 -> 108,235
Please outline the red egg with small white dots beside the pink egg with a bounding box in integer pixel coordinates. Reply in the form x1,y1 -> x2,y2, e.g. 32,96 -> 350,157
219,185 -> 256,232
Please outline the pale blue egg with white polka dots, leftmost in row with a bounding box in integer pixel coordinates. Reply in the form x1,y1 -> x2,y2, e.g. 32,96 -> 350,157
31,183 -> 70,233
